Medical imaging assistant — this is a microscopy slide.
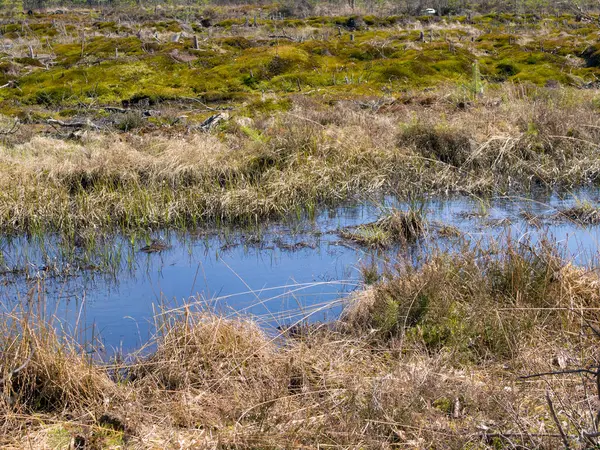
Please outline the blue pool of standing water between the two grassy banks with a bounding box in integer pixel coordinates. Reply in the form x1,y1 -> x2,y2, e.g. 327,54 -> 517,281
0,190 -> 600,354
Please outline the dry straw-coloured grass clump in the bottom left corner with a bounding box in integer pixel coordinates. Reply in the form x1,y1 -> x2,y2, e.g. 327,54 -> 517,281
0,313 -> 125,447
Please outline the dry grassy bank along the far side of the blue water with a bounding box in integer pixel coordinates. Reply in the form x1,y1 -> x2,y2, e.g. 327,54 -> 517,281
0,84 -> 600,235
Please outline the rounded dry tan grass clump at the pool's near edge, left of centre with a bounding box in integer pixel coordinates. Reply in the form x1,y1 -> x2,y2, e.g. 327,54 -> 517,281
131,314 -> 287,428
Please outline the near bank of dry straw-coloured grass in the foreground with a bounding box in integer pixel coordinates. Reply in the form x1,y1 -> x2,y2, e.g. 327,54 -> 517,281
0,240 -> 599,448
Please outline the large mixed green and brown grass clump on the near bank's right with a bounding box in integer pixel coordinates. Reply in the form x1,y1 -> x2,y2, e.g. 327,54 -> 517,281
345,236 -> 600,362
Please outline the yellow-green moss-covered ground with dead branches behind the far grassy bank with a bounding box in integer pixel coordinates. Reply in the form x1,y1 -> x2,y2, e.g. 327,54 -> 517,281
0,10 -> 600,122
